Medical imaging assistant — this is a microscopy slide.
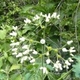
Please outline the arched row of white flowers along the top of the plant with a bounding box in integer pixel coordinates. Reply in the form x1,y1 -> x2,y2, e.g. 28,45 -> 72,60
24,12 -> 60,24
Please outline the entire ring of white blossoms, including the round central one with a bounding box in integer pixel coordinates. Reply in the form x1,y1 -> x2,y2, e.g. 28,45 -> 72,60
10,12 -> 76,74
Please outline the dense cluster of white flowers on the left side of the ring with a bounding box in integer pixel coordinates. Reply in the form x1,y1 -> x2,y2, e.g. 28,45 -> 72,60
10,27 -> 38,63
